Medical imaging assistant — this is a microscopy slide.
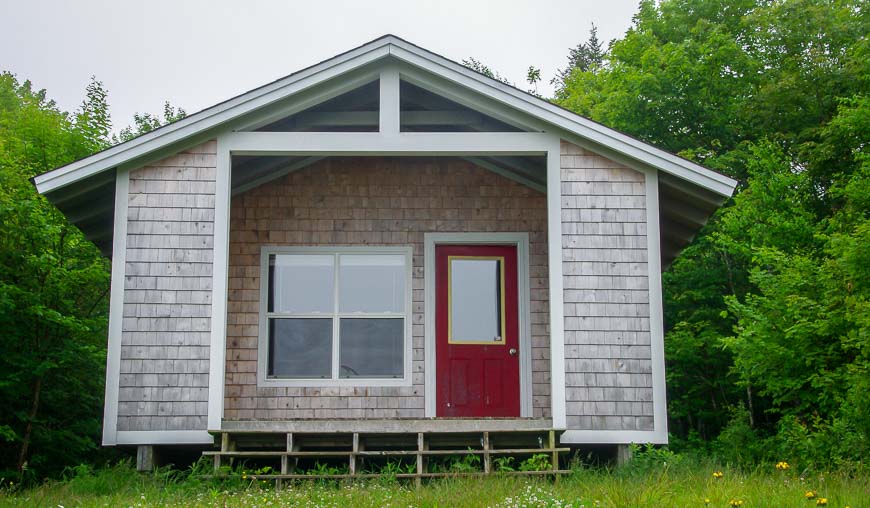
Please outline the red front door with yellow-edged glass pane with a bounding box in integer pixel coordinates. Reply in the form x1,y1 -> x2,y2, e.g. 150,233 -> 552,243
435,245 -> 520,417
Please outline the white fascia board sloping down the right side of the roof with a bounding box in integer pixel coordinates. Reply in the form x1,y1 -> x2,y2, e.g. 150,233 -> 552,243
390,39 -> 737,197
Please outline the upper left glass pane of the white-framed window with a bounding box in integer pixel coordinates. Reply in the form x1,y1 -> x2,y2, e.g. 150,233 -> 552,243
269,254 -> 335,314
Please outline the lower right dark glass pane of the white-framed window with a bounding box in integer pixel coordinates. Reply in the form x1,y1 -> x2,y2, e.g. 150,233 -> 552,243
338,318 -> 405,378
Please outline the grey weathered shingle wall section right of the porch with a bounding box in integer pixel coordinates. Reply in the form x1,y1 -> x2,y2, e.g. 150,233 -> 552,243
561,142 -> 653,430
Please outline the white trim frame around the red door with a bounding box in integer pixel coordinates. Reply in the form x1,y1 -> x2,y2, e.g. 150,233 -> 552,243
423,233 -> 532,418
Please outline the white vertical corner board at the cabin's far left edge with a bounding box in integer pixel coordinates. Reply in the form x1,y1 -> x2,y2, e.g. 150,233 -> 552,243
103,168 -> 130,446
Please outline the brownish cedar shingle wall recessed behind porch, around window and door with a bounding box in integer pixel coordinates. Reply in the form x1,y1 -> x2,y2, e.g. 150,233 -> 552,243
224,157 -> 550,420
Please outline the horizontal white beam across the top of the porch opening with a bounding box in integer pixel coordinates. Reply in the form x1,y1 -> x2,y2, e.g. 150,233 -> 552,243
220,132 -> 558,156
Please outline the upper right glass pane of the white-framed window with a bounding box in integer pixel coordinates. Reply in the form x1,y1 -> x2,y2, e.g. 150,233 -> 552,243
338,254 -> 406,313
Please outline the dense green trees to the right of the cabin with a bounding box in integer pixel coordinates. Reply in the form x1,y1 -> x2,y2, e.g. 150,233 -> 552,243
556,0 -> 870,465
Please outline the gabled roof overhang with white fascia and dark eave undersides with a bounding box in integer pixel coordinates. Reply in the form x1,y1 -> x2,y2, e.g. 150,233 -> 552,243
33,35 -> 737,265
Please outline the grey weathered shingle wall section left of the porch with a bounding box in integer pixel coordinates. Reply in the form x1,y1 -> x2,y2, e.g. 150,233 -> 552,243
118,141 -> 216,431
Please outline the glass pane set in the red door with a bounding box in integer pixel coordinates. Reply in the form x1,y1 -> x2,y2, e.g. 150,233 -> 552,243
448,258 -> 504,342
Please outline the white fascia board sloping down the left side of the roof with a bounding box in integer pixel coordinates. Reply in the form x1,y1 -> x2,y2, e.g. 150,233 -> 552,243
33,44 -> 389,194
